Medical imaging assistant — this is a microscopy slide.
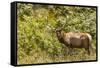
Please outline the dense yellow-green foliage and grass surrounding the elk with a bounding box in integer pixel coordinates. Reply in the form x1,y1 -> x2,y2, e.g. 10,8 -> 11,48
17,3 -> 96,64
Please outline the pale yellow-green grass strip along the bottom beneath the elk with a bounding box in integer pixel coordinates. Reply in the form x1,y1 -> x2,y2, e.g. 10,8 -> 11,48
18,46 -> 96,64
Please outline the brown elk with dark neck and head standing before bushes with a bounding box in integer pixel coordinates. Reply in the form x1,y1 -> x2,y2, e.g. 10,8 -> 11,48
56,28 -> 92,54
